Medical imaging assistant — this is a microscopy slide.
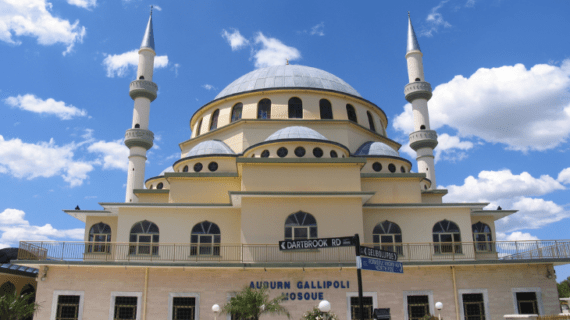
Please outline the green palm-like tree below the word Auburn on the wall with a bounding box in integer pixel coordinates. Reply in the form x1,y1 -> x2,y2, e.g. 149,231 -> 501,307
222,286 -> 291,320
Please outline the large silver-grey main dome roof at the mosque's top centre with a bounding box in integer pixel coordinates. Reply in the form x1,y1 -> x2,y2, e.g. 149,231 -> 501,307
215,65 -> 362,100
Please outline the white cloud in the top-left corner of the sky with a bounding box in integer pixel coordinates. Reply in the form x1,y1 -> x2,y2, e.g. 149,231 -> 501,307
0,0 -> 85,55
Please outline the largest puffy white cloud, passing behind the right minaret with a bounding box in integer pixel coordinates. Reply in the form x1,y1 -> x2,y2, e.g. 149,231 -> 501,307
394,60 -> 570,152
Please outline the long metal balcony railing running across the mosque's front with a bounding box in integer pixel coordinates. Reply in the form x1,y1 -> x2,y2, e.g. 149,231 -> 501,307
18,240 -> 570,263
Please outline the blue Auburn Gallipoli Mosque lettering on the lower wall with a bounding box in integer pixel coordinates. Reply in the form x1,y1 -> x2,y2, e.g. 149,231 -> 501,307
249,280 -> 350,301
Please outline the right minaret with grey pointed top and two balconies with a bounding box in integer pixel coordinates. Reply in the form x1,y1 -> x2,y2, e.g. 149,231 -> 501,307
404,12 -> 437,189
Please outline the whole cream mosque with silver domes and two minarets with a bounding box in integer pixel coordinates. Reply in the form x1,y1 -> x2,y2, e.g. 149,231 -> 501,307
12,10 -> 570,320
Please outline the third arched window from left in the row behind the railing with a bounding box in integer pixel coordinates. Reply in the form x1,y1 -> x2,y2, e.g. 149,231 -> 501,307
190,221 -> 221,256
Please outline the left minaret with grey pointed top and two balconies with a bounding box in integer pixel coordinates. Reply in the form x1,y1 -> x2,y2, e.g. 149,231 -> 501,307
125,7 -> 158,202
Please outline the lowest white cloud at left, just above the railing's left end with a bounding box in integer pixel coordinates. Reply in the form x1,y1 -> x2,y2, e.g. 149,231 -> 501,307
0,209 -> 85,248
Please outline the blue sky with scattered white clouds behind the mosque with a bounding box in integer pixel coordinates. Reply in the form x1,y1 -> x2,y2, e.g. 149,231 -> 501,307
0,0 -> 570,281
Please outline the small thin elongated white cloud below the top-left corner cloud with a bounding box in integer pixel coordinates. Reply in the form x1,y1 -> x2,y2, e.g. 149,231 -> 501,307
4,94 -> 87,120
